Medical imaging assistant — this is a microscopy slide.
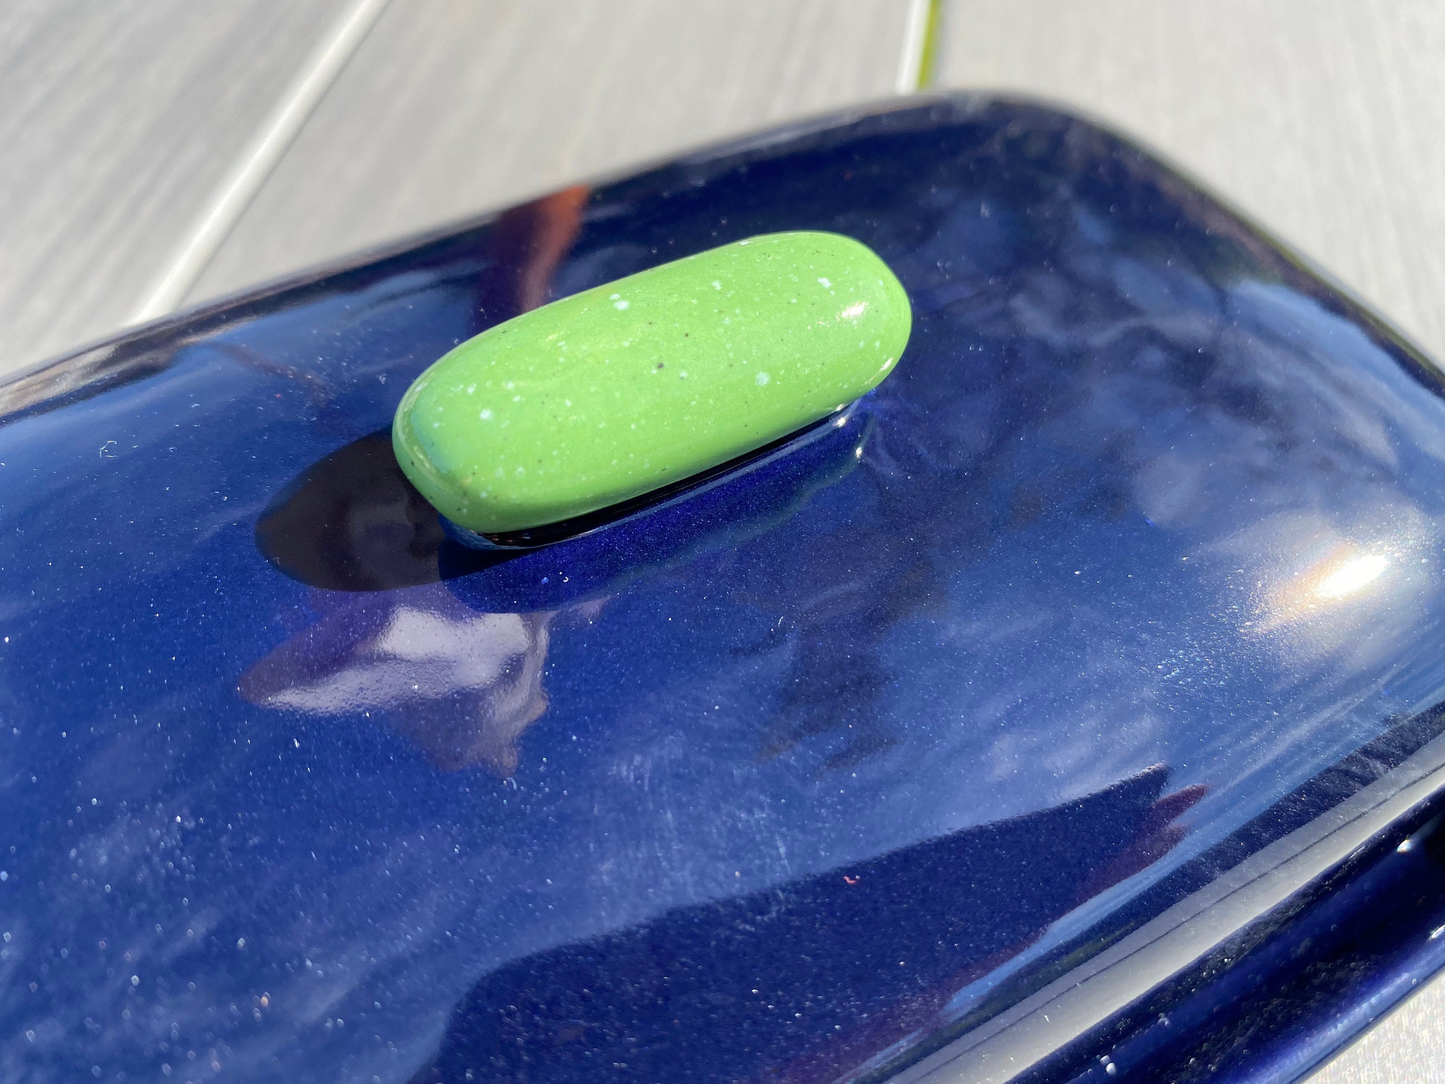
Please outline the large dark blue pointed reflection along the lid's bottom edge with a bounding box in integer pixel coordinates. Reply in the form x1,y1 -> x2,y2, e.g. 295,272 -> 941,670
416,769 -> 1199,1084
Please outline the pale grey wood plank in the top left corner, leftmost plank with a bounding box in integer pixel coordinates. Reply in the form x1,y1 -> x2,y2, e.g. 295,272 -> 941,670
0,0 -> 338,377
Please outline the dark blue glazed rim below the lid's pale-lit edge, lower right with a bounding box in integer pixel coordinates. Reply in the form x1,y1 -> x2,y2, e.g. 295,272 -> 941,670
1023,734 -> 1445,1084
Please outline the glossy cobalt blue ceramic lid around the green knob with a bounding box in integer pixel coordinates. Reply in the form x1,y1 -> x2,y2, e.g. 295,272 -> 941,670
0,98 -> 1445,1084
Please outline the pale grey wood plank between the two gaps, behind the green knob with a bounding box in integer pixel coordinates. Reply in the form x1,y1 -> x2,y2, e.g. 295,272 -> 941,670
191,0 -> 907,301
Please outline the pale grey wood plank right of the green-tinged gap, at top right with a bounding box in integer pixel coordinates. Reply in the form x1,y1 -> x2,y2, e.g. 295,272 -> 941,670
939,0 -> 1445,358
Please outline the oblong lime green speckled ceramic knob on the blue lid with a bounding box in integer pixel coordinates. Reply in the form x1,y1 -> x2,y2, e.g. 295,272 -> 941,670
392,233 -> 912,535
